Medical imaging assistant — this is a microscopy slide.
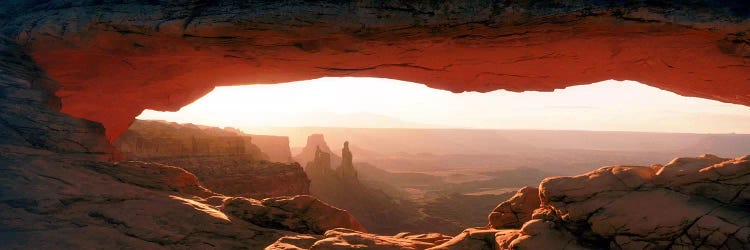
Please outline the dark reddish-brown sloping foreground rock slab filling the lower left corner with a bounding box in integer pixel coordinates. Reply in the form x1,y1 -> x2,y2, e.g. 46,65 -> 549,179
0,151 -> 363,249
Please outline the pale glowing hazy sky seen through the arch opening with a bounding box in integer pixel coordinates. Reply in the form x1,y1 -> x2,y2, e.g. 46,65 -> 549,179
138,77 -> 750,133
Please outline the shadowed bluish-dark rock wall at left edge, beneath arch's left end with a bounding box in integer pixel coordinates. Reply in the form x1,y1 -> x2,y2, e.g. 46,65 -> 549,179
0,37 -> 117,156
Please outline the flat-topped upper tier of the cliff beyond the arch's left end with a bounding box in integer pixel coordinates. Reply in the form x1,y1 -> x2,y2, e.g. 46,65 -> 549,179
114,120 -> 268,160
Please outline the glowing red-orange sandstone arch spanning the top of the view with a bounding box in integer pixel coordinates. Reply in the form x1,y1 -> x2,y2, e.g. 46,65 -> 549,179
0,1 -> 750,140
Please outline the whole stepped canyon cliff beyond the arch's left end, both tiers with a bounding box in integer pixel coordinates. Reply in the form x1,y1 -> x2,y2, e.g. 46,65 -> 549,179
114,120 -> 310,199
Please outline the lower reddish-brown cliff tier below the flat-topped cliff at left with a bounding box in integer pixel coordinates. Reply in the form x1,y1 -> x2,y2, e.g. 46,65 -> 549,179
153,155 -> 310,199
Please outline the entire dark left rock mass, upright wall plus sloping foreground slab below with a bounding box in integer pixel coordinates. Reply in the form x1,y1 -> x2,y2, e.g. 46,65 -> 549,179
0,40 -> 363,249
